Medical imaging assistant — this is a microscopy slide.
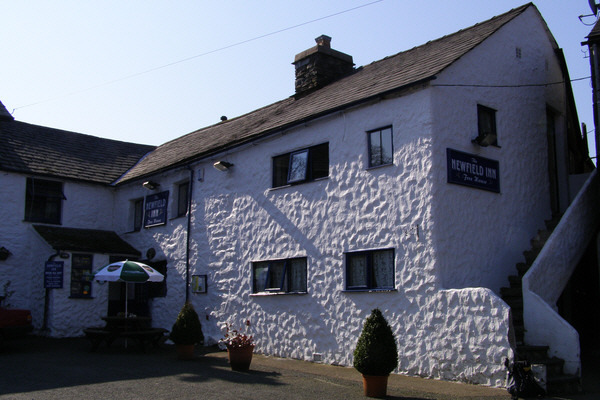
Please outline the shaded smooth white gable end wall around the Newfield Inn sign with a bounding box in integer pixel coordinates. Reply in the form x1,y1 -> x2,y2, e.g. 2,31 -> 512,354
432,10 -> 565,293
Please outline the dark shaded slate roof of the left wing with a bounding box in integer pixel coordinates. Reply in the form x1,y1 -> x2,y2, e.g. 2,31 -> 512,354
0,116 -> 155,184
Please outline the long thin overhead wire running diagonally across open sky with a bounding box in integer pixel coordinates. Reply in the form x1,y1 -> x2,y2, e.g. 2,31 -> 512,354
12,0 -> 383,114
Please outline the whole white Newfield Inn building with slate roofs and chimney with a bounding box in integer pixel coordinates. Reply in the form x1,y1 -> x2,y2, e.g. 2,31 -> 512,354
0,4 -> 590,385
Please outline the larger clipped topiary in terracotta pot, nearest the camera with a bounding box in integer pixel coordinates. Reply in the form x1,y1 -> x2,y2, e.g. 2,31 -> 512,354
354,308 -> 398,398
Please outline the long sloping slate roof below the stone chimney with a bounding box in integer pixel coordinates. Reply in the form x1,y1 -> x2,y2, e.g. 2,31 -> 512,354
119,3 -> 537,183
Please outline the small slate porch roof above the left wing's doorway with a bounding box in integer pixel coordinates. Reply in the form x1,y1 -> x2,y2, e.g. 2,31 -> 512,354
33,225 -> 141,257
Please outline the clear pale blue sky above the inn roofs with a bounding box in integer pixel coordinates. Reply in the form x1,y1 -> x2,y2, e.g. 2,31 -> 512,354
0,0 -> 595,161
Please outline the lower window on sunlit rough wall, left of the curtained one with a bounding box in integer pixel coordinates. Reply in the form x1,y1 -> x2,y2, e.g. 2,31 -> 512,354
252,258 -> 306,293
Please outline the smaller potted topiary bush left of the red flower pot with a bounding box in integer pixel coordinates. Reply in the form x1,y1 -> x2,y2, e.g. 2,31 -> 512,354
169,303 -> 204,359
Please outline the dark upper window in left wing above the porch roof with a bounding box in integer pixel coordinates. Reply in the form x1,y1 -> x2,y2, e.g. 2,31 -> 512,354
25,178 -> 66,224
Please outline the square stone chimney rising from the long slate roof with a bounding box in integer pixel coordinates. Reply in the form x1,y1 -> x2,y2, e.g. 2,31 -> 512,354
293,35 -> 354,98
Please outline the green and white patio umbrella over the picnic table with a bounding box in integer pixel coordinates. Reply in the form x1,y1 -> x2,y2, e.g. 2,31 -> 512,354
94,260 -> 165,317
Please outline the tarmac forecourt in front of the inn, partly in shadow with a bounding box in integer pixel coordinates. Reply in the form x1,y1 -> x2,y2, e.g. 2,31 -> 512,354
0,337 -> 597,400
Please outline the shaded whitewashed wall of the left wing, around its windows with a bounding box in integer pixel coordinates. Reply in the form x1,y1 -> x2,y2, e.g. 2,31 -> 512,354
0,173 -> 114,337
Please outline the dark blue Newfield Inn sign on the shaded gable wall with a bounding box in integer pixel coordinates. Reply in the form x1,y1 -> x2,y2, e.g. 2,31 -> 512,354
446,149 -> 500,193
